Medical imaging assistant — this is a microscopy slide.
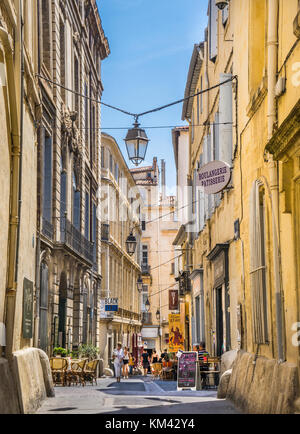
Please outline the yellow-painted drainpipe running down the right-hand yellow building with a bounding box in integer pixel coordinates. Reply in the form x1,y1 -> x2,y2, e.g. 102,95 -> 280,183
268,0 -> 285,362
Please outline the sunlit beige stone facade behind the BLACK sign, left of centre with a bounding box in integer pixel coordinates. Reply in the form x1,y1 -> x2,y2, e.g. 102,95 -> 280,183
99,133 -> 142,367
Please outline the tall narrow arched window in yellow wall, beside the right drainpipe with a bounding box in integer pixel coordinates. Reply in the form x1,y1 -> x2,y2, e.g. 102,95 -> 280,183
250,181 -> 268,344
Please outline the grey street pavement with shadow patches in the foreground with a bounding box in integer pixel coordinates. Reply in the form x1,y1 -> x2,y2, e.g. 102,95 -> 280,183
37,376 -> 239,414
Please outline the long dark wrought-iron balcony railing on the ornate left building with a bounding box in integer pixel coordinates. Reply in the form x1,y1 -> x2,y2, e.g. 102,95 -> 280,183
61,219 -> 94,264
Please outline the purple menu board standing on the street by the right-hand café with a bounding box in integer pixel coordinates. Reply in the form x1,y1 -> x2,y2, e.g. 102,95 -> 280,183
177,351 -> 198,390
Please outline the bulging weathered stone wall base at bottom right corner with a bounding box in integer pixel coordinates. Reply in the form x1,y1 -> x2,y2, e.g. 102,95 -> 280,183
226,351 -> 299,414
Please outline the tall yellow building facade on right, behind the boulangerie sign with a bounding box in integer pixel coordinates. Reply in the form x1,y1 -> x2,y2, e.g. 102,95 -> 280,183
181,0 -> 300,413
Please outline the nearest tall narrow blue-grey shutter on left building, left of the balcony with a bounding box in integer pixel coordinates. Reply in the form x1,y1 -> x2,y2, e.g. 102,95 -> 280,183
43,135 -> 52,222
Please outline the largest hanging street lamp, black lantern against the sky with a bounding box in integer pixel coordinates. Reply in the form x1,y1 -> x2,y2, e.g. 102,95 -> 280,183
124,116 -> 150,166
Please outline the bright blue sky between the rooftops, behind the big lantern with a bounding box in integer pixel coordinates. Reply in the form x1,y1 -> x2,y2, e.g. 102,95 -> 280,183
98,0 -> 208,188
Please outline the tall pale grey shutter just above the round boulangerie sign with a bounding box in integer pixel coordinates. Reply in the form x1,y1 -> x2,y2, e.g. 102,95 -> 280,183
219,74 -> 233,166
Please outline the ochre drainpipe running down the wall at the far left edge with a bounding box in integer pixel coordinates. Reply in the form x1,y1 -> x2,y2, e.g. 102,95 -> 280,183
0,0 -> 24,358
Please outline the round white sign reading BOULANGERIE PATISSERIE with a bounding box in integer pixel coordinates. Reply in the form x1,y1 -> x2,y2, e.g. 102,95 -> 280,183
197,161 -> 231,194
